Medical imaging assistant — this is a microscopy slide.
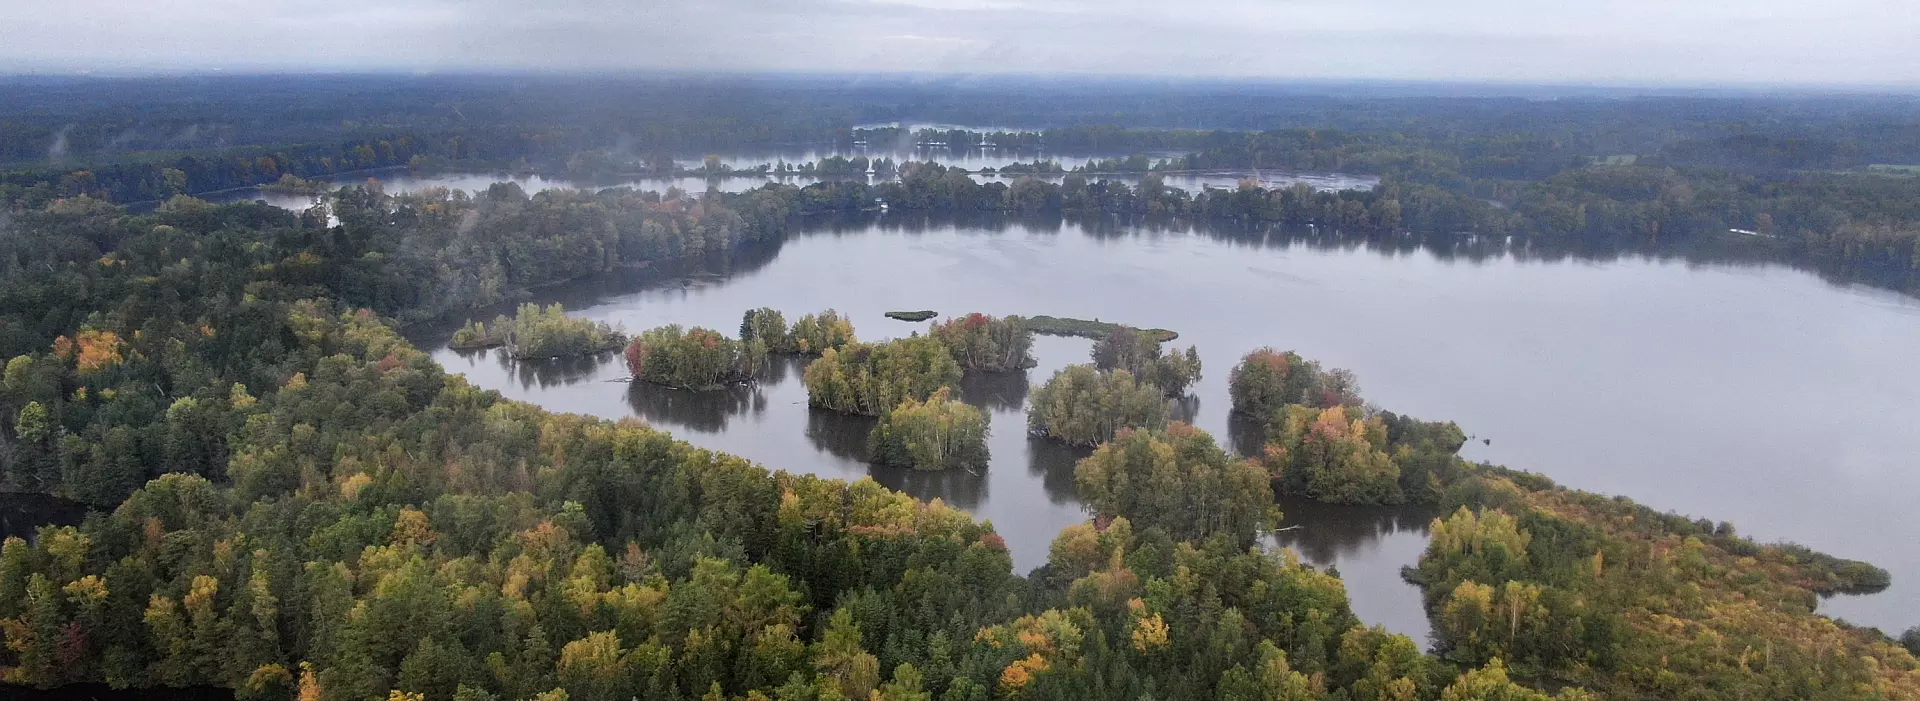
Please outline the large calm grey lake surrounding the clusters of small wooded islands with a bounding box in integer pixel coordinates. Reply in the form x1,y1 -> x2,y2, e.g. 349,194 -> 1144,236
419,213 -> 1920,638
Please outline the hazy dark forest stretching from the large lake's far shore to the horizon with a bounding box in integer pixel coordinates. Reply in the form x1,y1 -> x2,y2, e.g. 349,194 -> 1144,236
11,77 -> 1920,290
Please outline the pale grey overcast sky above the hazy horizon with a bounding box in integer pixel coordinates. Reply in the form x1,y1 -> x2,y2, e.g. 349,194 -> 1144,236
0,0 -> 1920,85
